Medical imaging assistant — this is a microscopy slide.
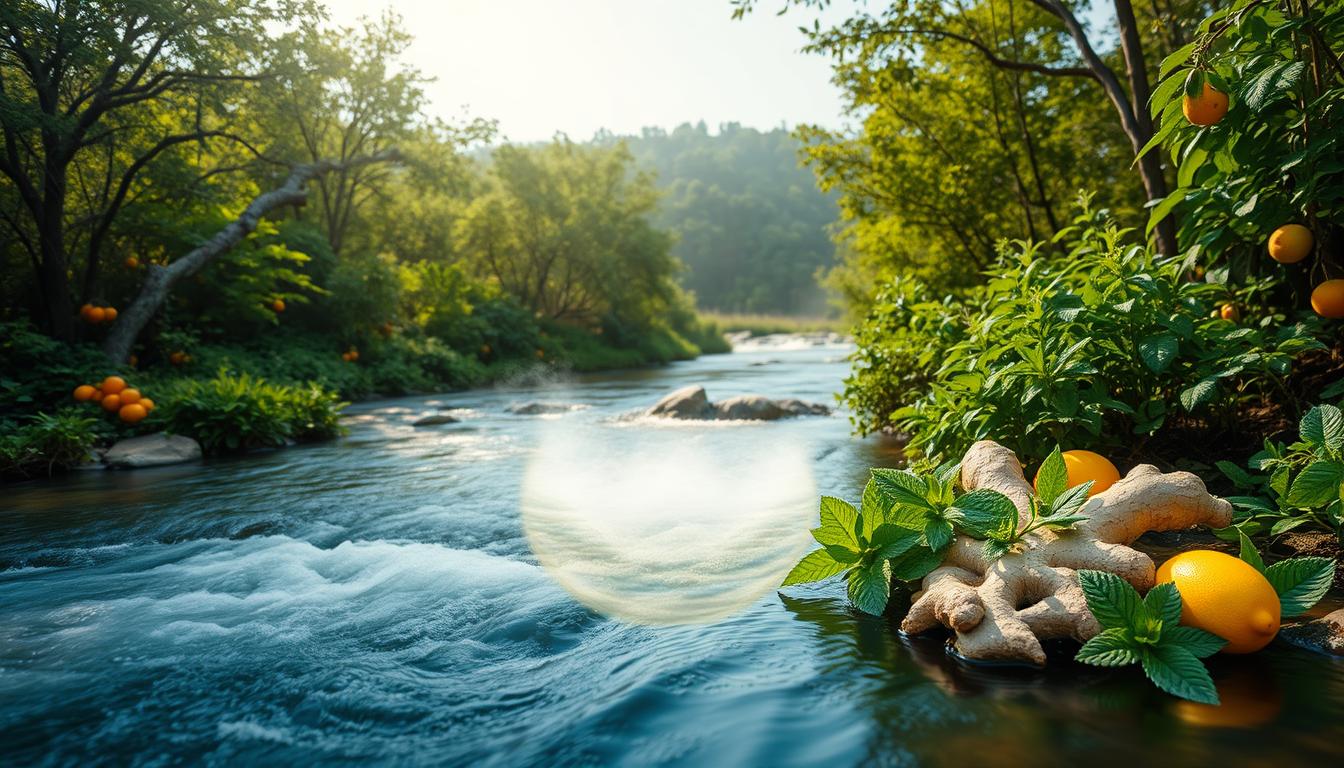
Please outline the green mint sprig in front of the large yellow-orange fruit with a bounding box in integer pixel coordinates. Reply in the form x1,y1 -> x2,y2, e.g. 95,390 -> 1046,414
1074,570 -> 1226,705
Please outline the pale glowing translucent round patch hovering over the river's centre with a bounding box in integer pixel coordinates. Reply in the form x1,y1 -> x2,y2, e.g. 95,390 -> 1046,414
521,425 -> 817,624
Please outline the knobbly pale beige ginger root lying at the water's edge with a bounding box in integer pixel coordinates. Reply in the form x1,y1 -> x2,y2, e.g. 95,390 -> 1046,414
900,440 -> 1232,664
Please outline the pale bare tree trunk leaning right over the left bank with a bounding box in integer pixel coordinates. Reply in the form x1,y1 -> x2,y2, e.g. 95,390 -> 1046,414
102,149 -> 401,363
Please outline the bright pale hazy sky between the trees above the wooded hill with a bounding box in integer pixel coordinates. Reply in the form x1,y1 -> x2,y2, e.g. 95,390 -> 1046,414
324,0 -> 847,141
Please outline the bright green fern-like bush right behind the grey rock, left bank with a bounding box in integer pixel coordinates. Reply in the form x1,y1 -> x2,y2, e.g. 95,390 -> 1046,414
151,370 -> 345,453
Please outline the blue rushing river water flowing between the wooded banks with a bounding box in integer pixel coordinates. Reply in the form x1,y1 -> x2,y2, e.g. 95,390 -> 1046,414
0,343 -> 1344,765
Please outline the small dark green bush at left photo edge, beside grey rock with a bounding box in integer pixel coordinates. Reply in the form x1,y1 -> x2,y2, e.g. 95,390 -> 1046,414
0,409 -> 99,477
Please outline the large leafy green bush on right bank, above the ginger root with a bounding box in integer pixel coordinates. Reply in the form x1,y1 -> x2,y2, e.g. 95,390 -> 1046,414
845,205 -> 1324,461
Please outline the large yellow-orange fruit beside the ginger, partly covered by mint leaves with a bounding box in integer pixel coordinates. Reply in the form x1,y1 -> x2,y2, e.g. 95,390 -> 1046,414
1156,549 -> 1281,654
